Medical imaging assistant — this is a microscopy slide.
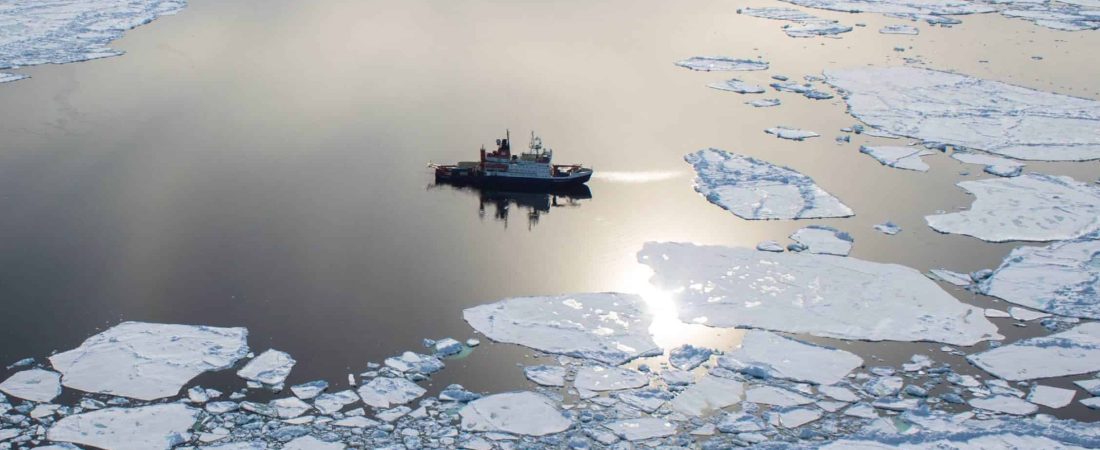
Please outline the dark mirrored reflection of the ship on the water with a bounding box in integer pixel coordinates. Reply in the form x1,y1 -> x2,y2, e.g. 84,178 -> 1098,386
429,180 -> 592,230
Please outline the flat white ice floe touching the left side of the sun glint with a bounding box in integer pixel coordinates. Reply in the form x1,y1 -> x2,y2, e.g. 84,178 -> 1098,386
462,293 -> 662,365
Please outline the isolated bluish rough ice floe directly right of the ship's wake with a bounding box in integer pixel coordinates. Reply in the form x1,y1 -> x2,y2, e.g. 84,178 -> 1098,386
684,149 -> 853,220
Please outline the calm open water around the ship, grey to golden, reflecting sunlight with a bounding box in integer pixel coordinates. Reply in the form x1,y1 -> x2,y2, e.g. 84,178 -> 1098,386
0,0 -> 1100,420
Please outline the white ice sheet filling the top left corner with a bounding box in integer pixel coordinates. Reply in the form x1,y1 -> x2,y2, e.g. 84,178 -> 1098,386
0,0 -> 187,83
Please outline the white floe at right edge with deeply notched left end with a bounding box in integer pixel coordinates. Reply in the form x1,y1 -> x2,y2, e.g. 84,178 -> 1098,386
924,172 -> 1100,242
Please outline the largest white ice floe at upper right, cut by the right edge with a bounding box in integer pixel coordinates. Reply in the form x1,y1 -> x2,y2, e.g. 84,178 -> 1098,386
825,67 -> 1100,161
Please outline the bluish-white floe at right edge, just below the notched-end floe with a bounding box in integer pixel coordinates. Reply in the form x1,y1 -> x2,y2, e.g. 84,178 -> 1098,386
978,232 -> 1100,319
